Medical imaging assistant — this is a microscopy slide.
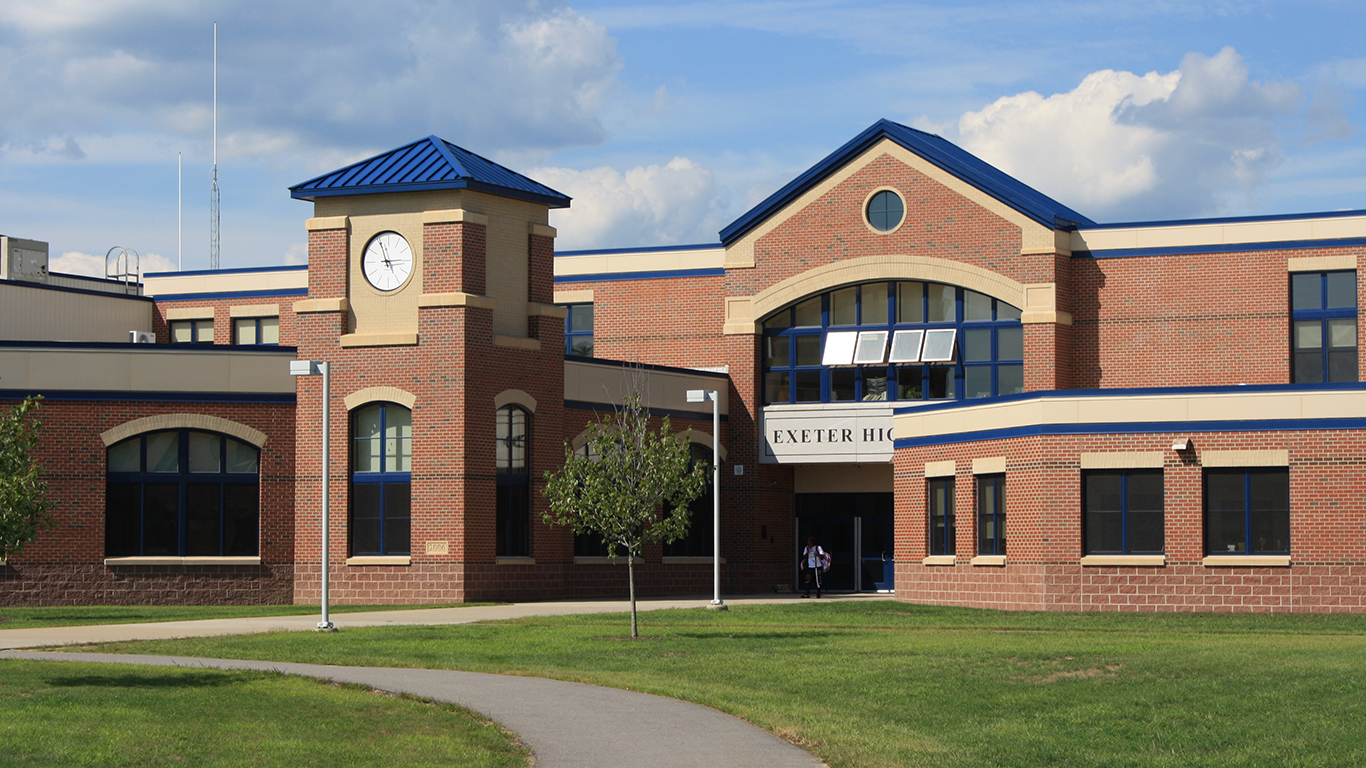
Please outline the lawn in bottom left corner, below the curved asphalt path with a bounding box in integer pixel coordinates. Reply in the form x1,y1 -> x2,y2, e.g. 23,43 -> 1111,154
0,660 -> 529,768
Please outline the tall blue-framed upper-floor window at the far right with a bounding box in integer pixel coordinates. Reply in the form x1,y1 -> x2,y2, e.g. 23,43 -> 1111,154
1290,271 -> 1358,384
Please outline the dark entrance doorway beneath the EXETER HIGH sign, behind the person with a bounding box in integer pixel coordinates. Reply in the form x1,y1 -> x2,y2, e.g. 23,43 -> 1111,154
792,493 -> 893,592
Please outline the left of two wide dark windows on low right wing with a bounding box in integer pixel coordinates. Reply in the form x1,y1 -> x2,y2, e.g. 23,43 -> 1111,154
1082,470 -> 1165,555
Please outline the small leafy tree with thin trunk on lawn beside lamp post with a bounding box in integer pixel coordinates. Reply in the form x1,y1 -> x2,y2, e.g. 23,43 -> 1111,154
544,389 -> 708,638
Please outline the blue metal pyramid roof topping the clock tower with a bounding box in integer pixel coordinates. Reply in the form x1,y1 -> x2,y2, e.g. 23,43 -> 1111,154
290,137 -> 570,208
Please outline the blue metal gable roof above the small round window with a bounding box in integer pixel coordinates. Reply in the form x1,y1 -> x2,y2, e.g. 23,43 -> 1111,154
721,120 -> 1094,245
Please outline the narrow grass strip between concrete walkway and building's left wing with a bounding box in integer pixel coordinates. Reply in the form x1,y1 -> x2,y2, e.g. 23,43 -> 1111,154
0,603 -> 490,630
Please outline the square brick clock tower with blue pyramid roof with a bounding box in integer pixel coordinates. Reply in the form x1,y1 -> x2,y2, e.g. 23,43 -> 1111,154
290,137 -> 572,603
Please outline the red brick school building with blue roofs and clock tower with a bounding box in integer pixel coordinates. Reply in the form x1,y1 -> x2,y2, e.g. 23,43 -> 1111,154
0,120 -> 1366,611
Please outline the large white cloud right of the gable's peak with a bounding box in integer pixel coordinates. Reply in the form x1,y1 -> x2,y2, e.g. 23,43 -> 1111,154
958,48 -> 1303,221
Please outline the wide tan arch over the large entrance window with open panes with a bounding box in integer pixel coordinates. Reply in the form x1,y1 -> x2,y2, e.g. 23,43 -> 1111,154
748,254 -> 1026,321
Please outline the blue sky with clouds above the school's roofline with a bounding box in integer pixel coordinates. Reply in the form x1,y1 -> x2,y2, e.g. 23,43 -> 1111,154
0,0 -> 1366,273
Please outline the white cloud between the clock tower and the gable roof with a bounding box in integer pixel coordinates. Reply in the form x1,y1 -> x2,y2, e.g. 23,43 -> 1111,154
529,157 -> 727,250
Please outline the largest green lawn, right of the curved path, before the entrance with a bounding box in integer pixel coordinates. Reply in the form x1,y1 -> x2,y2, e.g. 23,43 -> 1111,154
66,600 -> 1366,768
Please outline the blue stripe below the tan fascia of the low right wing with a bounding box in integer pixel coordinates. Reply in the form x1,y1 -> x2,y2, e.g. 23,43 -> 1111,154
892,418 -> 1366,448
